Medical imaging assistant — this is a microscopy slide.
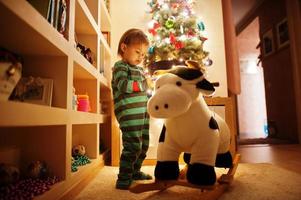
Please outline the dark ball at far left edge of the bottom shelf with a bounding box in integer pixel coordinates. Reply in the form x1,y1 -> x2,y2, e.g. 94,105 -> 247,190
0,163 -> 20,187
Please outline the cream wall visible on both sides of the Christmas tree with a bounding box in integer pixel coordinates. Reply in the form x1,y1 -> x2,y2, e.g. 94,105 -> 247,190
111,0 -> 228,97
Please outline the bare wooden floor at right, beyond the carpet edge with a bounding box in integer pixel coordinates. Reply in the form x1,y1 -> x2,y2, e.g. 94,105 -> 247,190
238,144 -> 301,174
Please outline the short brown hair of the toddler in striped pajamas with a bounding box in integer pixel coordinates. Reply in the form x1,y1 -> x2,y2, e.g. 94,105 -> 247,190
117,28 -> 149,56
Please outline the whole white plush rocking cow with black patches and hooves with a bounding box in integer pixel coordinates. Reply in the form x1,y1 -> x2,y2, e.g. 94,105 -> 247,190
147,66 -> 232,185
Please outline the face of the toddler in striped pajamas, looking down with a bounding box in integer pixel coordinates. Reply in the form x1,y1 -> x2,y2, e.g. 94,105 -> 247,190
122,44 -> 148,65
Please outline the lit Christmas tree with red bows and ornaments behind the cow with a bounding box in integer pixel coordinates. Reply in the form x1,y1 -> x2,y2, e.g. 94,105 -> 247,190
145,0 -> 212,73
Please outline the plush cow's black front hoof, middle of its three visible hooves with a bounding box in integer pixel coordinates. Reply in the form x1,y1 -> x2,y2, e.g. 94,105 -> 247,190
187,163 -> 216,185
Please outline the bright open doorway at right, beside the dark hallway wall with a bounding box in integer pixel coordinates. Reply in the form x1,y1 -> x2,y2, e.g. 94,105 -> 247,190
237,17 -> 268,142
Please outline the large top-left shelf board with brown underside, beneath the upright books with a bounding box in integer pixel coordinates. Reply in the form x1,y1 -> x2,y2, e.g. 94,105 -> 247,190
0,0 -> 70,56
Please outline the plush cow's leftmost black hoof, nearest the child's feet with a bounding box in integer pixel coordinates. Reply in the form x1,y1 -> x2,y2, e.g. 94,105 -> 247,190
155,161 -> 180,180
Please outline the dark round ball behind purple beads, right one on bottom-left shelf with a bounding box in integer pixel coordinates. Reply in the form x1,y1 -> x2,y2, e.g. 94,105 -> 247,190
26,160 -> 49,179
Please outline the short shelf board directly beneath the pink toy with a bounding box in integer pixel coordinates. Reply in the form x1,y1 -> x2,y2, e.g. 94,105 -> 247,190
71,111 -> 105,124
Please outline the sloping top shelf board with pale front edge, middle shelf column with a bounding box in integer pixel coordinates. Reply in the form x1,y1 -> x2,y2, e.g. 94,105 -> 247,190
75,0 -> 98,35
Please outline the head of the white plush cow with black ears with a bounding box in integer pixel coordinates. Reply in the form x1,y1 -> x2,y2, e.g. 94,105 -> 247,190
147,66 -> 215,118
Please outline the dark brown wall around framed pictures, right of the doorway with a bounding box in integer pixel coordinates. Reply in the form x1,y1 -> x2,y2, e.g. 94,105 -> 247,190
258,0 -> 298,142
